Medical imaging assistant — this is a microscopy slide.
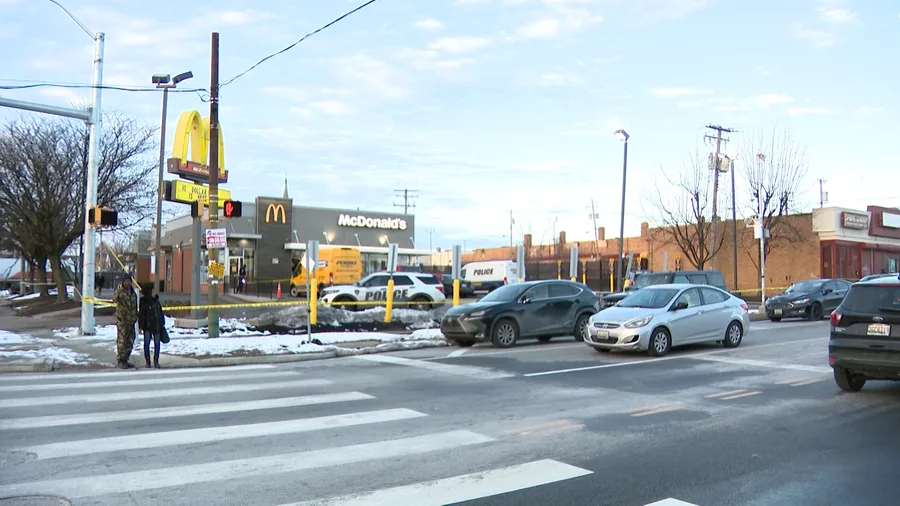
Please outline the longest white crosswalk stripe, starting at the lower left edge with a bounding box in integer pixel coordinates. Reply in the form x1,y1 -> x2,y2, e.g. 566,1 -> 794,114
0,430 -> 494,499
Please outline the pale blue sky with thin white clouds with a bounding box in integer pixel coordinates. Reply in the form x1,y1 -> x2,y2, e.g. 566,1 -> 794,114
0,0 -> 900,249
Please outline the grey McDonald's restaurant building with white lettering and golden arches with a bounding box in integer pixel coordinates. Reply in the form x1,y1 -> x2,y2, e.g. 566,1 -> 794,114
162,195 -> 430,295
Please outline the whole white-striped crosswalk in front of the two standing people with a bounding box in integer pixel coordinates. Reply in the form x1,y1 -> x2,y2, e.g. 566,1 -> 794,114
0,364 -> 592,506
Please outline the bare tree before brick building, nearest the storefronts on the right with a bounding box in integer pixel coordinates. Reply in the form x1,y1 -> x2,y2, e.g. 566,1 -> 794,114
740,128 -> 810,273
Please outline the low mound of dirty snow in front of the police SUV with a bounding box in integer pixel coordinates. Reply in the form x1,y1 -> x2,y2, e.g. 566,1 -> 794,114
253,306 -> 440,330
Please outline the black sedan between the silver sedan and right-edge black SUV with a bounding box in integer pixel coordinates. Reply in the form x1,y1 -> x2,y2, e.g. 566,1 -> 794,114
766,279 -> 850,322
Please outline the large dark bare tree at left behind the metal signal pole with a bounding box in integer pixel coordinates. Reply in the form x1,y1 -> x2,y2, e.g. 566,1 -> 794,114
0,113 -> 156,300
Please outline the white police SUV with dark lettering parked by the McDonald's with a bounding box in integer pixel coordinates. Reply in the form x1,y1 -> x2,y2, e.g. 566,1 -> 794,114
319,272 -> 446,311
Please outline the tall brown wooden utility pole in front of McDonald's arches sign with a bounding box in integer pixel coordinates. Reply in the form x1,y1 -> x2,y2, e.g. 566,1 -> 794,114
207,32 -> 219,338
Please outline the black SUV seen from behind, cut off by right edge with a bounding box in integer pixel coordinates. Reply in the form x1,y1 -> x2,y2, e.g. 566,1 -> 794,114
828,277 -> 900,392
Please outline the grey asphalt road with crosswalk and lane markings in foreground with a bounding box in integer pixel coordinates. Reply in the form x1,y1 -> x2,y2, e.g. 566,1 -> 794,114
0,322 -> 900,506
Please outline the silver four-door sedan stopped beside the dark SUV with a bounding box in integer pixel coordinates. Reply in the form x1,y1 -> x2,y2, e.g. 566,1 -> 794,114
585,284 -> 750,357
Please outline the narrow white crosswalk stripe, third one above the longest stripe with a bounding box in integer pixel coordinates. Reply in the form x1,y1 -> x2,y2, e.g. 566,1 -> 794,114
0,379 -> 332,409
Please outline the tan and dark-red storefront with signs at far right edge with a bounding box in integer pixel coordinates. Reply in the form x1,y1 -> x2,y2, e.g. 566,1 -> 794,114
813,206 -> 900,280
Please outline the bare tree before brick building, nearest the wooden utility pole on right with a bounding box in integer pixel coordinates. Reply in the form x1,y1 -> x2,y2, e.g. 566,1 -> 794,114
645,149 -> 725,269
